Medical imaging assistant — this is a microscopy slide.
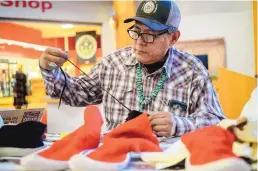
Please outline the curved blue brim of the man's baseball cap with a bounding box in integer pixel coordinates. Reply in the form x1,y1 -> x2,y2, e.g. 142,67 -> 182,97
124,17 -> 169,31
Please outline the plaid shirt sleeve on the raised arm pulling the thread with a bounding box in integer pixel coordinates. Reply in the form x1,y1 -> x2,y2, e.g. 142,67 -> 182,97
40,62 -> 103,106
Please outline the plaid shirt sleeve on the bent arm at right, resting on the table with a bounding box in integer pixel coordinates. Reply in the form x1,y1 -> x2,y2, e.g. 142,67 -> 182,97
173,64 -> 225,136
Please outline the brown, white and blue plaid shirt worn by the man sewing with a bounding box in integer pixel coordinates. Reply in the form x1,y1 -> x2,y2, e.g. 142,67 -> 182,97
41,46 -> 225,136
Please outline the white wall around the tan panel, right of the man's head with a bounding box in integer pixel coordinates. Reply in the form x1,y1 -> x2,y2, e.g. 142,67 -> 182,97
180,10 -> 255,77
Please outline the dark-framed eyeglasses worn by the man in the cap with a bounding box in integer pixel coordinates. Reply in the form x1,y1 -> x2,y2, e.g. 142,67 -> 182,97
127,25 -> 168,43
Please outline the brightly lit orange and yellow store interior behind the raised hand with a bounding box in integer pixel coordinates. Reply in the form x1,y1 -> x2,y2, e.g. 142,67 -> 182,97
0,21 -> 102,108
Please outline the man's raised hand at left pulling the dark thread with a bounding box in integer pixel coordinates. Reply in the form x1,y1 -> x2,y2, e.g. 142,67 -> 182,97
39,47 -> 68,71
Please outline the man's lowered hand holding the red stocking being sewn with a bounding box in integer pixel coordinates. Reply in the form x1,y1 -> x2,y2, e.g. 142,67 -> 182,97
149,112 -> 175,137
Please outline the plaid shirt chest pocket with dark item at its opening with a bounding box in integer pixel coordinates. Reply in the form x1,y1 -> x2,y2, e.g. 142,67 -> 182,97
160,88 -> 188,117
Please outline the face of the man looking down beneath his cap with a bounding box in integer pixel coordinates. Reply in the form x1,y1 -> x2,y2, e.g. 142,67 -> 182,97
133,23 -> 172,64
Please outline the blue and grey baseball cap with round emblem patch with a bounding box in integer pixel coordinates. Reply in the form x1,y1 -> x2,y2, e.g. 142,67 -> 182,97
124,0 -> 181,32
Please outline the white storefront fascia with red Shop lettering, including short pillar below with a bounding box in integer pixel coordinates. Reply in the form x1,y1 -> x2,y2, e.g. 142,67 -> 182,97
0,0 -> 116,56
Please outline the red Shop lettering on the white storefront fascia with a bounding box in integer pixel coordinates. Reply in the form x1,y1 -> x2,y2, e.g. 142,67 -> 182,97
0,0 -> 53,12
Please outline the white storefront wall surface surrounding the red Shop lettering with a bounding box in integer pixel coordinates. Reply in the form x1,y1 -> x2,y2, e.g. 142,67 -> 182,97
0,1 -> 116,56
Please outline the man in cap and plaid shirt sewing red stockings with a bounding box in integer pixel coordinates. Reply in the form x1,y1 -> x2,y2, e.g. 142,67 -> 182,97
40,1 -> 224,137
